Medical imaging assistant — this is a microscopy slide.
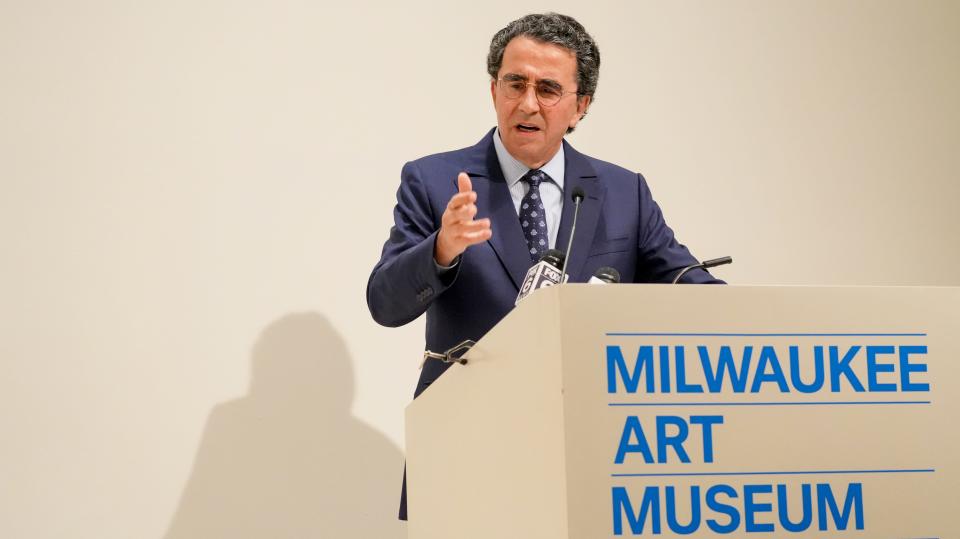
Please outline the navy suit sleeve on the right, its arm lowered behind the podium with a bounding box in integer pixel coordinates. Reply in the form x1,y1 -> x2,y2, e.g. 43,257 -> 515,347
636,174 -> 725,284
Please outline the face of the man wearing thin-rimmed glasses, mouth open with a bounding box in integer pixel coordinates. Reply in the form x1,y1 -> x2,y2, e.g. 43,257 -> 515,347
490,36 -> 590,168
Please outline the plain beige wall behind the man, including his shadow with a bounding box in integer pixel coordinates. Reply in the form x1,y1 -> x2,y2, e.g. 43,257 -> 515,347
0,0 -> 960,539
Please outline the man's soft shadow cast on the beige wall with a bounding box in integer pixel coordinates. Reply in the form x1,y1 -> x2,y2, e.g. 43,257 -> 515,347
166,313 -> 406,539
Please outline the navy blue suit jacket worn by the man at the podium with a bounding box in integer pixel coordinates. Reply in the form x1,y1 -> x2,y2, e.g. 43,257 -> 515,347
367,130 -> 722,519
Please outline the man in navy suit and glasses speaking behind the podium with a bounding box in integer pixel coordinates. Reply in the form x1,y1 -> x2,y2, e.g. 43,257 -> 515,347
367,13 -> 721,519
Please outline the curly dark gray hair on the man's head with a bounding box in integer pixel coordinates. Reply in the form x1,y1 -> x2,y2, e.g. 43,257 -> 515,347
487,13 -> 600,100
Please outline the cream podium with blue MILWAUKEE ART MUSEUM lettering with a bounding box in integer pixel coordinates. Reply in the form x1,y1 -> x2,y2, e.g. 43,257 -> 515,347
406,285 -> 960,539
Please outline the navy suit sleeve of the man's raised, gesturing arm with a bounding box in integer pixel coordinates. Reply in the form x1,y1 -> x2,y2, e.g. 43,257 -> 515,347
367,162 -> 459,327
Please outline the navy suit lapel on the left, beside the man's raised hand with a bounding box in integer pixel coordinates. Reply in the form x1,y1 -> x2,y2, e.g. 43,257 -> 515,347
462,131 -> 528,290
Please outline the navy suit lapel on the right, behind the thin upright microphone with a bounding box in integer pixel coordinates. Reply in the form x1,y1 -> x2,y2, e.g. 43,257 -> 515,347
552,140 -> 606,281
